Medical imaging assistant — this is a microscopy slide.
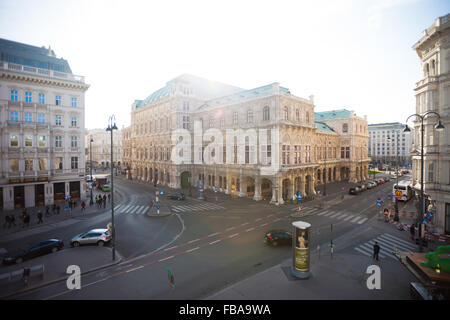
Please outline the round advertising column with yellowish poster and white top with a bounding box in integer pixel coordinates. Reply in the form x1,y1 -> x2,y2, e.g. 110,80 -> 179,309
291,221 -> 311,279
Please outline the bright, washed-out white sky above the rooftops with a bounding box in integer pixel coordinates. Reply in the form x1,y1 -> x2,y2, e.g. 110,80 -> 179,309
0,0 -> 450,129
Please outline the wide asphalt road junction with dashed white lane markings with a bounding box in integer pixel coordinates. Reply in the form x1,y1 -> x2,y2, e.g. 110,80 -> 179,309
5,175 -> 404,299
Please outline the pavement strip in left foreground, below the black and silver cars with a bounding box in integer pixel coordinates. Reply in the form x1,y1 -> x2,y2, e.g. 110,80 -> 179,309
0,244 -> 122,299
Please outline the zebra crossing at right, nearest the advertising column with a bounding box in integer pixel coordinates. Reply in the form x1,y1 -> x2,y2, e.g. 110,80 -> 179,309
354,233 -> 417,260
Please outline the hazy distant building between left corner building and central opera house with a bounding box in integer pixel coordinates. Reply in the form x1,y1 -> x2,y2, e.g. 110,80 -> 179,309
85,129 -> 123,171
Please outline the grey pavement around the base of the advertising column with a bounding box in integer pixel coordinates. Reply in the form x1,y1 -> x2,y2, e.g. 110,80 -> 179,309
205,253 -> 414,300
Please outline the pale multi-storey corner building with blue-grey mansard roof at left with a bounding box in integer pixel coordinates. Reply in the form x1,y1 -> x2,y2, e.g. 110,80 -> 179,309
0,39 -> 89,211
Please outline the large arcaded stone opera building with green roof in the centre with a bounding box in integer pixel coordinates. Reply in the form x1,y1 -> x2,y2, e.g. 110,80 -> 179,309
123,74 -> 370,204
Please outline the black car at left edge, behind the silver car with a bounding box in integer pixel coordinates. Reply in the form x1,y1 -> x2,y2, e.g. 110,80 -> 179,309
3,239 -> 64,264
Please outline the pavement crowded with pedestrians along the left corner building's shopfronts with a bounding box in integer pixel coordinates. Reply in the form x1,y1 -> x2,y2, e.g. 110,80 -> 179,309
0,191 -> 121,238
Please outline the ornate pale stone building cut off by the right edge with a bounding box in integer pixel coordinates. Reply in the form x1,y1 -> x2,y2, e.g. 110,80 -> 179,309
412,14 -> 450,234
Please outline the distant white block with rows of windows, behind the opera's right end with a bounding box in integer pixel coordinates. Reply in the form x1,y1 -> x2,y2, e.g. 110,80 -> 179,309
369,122 -> 412,167
